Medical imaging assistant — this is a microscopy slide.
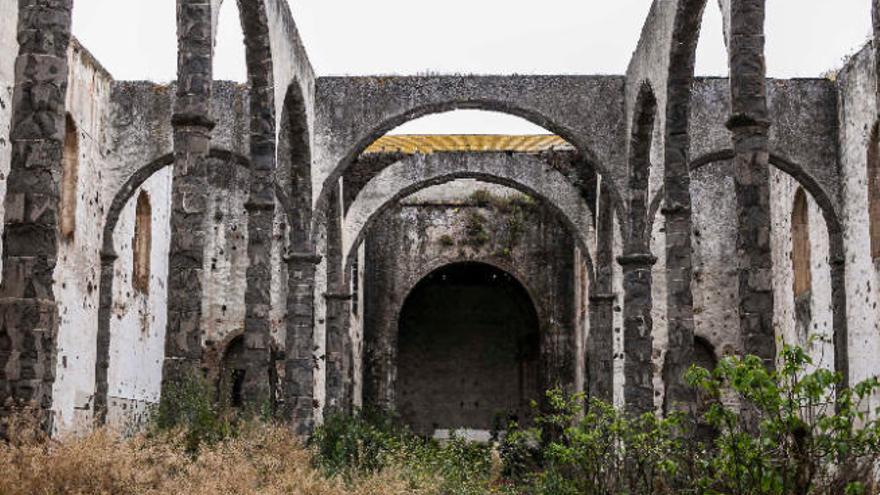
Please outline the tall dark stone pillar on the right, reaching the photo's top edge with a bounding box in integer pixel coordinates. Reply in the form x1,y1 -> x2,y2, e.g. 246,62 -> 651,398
727,0 -> 776,367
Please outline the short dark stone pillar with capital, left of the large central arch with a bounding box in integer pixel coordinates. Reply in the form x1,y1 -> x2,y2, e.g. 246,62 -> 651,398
283,252 -> 321,435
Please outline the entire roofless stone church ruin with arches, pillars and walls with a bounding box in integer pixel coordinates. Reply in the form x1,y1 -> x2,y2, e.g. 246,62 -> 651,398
0,0 -> 880,435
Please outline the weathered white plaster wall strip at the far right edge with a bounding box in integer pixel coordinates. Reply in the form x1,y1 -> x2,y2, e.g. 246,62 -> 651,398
838,46 -> 880,392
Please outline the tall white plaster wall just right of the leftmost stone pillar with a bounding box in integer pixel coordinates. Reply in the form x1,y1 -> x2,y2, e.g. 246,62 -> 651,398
52,42 -> 112,435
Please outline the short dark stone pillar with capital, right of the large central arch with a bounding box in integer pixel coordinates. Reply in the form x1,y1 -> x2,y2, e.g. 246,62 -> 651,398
617,252 -> 657,414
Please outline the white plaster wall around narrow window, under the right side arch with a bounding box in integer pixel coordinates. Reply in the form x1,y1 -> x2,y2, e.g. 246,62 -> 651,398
770,168 -> 834,370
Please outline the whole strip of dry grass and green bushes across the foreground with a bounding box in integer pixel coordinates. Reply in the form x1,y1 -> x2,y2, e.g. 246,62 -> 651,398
0,347 -> 880,495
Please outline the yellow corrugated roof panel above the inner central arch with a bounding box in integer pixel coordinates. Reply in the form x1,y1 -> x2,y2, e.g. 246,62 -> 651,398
364,134 -> 574,155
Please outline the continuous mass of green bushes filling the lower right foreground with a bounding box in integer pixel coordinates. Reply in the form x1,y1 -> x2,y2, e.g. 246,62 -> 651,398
501,346 -> 880,495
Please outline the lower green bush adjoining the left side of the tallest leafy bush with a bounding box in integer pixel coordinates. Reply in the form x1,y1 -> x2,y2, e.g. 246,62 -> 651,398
502,389 -> 689,495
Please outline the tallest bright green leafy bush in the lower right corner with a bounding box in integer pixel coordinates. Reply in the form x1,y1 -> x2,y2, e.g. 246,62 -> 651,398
688,346 -> 880,495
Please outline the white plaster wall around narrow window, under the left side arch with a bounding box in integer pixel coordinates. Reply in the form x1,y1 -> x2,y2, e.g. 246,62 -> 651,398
107,167 -> 173,431
